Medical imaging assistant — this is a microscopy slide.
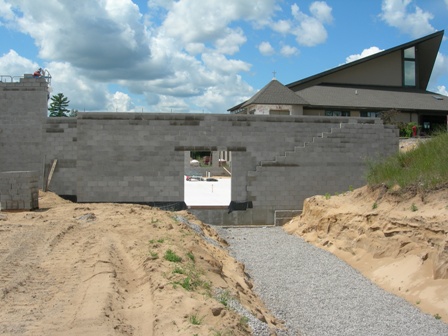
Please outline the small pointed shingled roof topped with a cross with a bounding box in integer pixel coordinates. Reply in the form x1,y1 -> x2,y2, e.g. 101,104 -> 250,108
240,78 -> 307,107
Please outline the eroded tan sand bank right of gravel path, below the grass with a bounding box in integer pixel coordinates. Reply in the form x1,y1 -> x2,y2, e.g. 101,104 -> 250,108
284,187 -> 448,322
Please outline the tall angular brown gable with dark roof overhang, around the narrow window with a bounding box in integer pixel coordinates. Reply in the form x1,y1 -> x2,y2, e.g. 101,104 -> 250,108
286,30 -> 444,92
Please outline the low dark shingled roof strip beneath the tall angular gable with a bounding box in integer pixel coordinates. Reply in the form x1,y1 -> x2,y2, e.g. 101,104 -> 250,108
297,85 -> 448,112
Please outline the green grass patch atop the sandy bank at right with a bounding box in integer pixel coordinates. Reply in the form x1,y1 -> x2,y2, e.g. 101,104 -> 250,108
367,133 -> 448,191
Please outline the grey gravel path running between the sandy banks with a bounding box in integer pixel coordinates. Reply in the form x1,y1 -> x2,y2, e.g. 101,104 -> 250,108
217,227 -> 448,336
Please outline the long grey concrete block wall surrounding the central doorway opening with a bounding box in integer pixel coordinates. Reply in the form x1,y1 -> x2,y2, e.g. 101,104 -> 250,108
76,113 -> 398,210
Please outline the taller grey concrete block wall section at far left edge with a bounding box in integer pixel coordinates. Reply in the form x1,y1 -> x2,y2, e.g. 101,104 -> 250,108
0,77 -> 48,185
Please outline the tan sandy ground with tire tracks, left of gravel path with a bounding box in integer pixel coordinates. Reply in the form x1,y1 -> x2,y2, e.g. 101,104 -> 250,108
0,193 -> 282,336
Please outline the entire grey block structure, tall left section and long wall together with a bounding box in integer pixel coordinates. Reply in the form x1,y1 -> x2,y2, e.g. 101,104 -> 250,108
0,78 -> 398,225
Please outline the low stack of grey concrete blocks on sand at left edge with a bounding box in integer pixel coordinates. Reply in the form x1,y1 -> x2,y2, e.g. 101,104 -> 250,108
0,171 -> 39,210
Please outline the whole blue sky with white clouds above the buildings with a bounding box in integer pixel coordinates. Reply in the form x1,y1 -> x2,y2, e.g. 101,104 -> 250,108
0,0 -> 448,113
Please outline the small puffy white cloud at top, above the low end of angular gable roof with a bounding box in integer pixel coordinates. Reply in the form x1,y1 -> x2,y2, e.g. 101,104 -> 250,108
291,1 -> 333,47
